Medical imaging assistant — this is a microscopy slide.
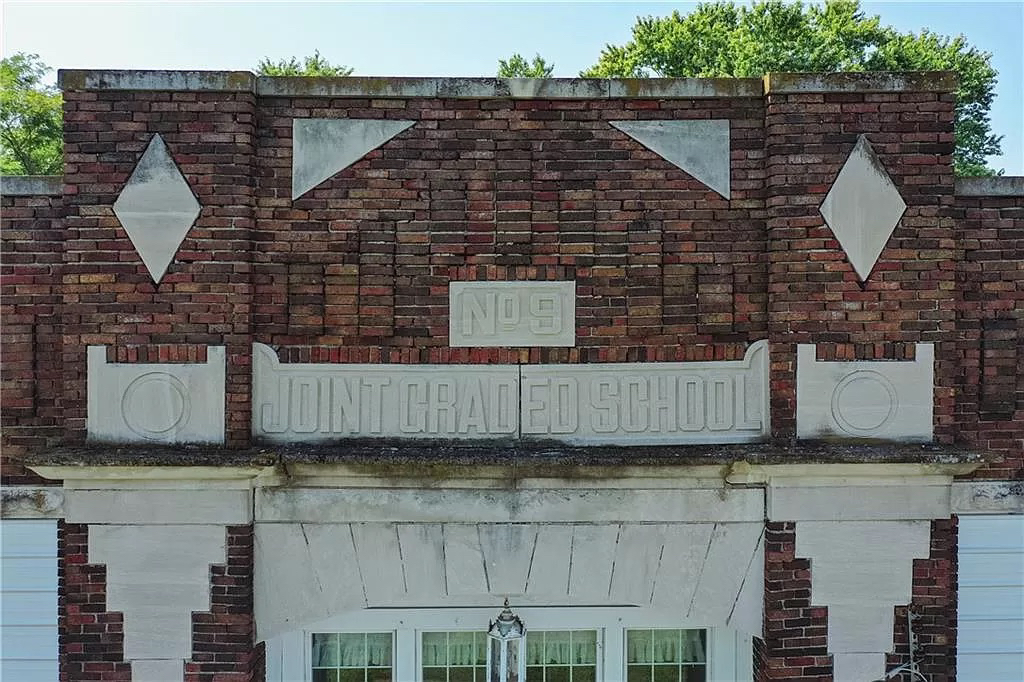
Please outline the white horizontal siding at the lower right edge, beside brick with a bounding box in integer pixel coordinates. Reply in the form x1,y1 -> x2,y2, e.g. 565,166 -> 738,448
956,516 -> 1024,682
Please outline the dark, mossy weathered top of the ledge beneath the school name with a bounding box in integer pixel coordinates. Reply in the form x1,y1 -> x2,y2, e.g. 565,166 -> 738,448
29,439 -> 996,467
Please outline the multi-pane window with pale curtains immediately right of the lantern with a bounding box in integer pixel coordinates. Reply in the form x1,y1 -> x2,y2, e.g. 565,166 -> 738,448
526,630 -> 597,682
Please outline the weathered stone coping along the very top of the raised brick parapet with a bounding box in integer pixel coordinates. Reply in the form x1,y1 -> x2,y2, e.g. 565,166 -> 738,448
57,70 -> 956,99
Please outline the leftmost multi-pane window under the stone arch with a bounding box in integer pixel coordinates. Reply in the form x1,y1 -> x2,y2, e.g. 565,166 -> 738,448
312,632 -> 394,682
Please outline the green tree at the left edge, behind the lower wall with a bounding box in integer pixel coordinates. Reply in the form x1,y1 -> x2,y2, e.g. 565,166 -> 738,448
0,52 -> 63,175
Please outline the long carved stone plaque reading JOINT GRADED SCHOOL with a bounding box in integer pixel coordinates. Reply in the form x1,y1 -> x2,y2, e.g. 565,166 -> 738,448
253,341 -> 769,444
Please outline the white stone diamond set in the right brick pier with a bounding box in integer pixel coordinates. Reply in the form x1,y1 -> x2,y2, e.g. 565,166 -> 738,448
819,135 -> 906,282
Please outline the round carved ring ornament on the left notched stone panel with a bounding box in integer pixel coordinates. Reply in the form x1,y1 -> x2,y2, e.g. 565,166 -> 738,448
121,372 -> 191,440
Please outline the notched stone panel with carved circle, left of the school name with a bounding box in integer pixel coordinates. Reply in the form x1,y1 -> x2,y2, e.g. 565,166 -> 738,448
86,346 -> 225,443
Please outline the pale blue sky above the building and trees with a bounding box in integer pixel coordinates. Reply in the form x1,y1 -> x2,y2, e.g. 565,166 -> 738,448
6,0 -> 1024,175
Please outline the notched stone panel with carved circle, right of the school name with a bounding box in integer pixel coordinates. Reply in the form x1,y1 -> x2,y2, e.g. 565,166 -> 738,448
797,343 -> 934,442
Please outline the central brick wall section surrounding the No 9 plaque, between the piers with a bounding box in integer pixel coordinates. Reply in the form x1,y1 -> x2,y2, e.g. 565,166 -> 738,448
253,97 -> 766,364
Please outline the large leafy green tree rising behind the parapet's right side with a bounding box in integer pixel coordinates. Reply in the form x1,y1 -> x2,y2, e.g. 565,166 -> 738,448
581,0 -> 1001,175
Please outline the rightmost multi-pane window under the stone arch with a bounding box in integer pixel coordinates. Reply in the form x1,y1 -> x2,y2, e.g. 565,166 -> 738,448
626,629 -> 708,682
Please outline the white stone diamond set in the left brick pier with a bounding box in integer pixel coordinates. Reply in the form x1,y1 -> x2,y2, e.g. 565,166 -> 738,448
114,134 -> 200,284
